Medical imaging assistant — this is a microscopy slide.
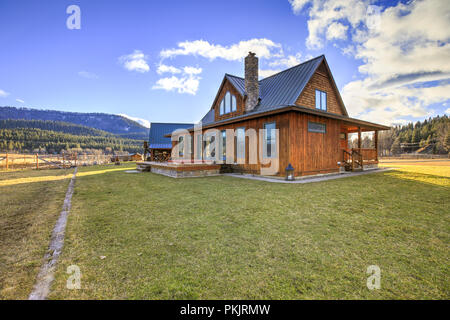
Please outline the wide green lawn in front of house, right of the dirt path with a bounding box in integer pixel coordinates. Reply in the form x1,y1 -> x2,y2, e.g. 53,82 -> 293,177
46,165 -> 450,299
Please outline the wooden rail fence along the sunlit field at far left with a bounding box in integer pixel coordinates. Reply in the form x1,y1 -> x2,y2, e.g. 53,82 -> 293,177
0,153 -> 111,171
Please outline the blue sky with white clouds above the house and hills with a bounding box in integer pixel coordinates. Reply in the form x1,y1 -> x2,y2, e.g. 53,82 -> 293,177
0,0 -> 450,124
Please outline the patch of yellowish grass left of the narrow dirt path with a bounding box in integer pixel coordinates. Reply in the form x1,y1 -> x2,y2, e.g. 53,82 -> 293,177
0,170 -> 72,299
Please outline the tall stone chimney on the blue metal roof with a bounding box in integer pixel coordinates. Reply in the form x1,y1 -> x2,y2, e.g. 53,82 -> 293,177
245,52 -> 259,112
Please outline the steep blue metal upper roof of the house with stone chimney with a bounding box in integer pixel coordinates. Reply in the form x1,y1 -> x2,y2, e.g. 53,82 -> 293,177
202,55 -> 325,125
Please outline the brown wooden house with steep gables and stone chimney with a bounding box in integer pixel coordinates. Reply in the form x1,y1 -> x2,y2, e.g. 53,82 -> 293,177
167,53 -> 389,176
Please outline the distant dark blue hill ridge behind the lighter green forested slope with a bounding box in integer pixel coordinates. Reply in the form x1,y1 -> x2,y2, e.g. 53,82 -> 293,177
0,107 -> 148,140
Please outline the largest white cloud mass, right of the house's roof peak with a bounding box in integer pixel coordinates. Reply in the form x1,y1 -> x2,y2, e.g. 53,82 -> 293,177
293,0 -> 450,124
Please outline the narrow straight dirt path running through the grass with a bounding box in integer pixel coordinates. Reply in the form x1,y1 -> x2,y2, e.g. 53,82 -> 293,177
28,168 -> 78,300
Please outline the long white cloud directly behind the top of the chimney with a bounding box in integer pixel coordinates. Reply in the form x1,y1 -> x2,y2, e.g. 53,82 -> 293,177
160,38 -> 282,61
